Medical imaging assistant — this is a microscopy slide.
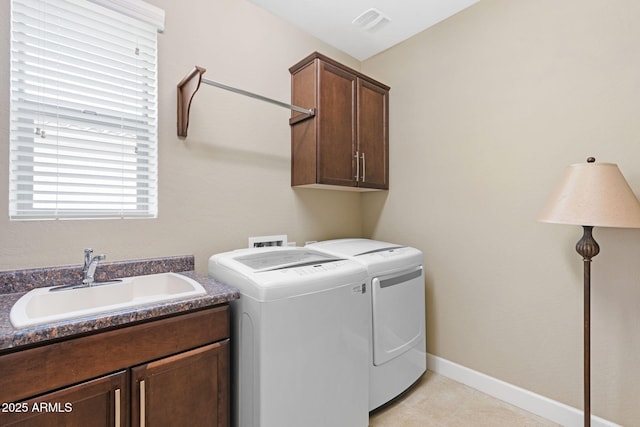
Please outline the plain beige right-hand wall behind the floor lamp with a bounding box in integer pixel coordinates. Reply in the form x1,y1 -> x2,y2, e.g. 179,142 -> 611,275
362,0 -> 640,426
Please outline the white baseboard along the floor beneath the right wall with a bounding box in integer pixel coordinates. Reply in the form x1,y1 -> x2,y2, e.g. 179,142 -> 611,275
427,353 -> 622,427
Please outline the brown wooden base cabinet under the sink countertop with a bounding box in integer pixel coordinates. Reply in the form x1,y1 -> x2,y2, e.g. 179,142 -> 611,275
0,305 -> 230,427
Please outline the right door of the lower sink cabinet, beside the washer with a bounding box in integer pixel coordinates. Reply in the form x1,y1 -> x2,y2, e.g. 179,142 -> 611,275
131,340 -> 229,426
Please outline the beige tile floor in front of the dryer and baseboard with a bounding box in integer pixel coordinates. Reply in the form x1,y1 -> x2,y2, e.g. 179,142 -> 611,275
369,371 -> 559,427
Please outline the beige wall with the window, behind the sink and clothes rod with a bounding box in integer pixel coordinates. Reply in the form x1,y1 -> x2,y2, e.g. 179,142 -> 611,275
0,0 -> 361,273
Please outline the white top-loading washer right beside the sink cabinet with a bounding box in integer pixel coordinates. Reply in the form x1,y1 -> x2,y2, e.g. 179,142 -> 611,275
209,247 -> 370,427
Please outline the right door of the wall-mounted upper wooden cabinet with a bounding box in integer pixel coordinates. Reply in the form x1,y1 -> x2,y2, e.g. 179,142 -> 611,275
357,79 -> 389,189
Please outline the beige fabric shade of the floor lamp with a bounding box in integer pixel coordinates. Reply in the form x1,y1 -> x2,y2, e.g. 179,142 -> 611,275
537,158 -> 640,228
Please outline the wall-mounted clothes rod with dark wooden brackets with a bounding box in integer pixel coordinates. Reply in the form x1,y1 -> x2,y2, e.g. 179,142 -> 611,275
178,65 -> 315,136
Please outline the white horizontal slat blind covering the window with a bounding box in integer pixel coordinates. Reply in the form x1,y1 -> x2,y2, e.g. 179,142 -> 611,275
9,0 -> 157,219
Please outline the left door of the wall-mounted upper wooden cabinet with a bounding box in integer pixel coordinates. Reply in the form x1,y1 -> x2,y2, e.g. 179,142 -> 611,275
317,61 -> 357,186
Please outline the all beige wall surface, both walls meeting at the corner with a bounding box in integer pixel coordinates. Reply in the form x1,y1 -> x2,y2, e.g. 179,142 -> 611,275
0,0 -> 640,425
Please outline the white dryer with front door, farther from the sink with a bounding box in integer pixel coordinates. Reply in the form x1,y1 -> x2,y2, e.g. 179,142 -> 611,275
306,239 -> 427,411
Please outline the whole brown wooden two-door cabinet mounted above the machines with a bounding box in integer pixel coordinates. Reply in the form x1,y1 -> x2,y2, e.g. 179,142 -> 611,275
289,52 -> 389,191
